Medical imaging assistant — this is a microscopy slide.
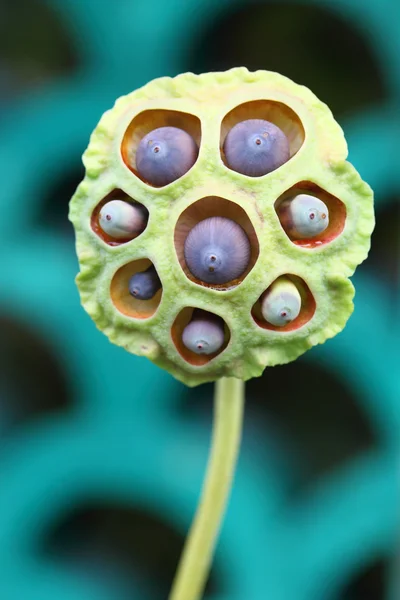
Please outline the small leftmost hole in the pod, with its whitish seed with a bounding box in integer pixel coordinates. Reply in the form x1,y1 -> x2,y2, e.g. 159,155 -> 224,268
91,190 -> 149,246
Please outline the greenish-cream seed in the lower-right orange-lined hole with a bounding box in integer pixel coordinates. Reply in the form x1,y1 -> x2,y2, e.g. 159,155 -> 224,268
261,277 -> 301,327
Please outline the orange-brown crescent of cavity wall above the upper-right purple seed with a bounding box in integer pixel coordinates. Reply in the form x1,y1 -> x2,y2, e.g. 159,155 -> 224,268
220,100 -> 306,169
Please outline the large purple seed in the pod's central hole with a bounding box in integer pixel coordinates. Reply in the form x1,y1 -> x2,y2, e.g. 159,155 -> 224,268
184,217 -> 251,284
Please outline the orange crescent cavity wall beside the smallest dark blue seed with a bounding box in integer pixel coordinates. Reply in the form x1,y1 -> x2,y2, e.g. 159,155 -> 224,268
110,258 -> 162,319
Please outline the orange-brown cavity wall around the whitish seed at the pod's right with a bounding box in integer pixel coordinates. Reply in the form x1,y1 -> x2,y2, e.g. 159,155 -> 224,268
275,181 -> 347,248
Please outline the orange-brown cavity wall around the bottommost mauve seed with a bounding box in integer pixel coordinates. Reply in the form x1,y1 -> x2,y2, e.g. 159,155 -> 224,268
171,307 -> 231,367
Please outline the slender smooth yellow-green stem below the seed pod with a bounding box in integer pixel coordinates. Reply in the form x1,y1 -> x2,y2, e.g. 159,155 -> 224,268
169,378 -> 244,600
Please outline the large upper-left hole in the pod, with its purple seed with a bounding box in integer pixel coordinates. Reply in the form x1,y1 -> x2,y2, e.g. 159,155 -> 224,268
121,109 -> 201,187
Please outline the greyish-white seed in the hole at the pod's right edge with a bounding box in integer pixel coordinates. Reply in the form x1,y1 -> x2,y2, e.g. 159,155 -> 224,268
278,194 -> 329,239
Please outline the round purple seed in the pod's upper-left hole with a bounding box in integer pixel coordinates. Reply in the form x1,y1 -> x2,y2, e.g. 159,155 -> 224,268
136,127 -> 199,186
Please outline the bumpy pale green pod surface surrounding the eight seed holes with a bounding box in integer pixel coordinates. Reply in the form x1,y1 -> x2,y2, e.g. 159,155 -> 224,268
70,68 -> 374,385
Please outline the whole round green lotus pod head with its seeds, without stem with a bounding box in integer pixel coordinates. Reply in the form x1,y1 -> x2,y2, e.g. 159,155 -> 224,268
70,68 -> 374,386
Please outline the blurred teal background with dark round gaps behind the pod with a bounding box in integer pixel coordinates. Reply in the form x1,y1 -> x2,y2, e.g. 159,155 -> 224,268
0,0 -> 400,600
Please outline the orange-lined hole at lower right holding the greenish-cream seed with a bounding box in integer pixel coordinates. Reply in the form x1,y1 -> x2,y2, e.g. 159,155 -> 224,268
252,274 -> 316,332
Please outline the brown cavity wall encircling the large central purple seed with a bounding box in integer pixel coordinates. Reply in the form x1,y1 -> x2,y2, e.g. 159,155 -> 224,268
174,196 -> 260,291
